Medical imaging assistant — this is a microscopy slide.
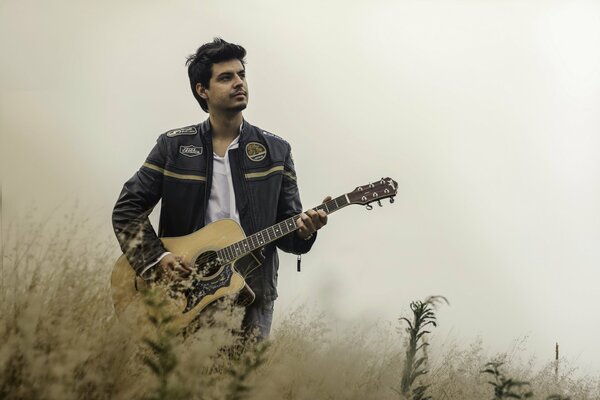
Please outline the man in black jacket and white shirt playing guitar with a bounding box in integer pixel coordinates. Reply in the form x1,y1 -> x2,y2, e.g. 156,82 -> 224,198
113,38 -> 330,338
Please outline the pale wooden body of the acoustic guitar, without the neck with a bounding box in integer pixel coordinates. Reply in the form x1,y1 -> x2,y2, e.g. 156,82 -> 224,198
111,219 -> 258,335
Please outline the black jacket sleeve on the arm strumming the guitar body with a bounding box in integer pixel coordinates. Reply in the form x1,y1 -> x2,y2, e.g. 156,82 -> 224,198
112,137 -> 167,274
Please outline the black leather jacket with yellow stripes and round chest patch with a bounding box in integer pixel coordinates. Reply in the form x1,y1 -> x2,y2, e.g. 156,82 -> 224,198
113,119 -> 316,300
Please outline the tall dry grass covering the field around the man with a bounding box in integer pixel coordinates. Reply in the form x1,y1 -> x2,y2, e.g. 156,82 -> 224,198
0,218 -> 600,400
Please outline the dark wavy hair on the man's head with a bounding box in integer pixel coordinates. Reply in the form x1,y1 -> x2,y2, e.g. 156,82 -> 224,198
185,38 -> 246,112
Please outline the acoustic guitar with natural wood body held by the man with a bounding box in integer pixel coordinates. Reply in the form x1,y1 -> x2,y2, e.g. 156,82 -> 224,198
111,178 -> 398,334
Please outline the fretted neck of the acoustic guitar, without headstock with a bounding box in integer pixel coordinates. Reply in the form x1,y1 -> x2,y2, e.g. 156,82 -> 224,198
217,194 -> 351,264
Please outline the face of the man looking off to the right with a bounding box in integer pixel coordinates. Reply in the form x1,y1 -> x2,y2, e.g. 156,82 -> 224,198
196,60 -> 248,113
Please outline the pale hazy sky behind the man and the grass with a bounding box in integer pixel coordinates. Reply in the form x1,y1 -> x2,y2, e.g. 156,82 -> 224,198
0,0 -> 600,374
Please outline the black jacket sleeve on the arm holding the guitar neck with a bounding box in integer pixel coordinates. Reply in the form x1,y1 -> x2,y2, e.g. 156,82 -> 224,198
276,146 -> 317,254
